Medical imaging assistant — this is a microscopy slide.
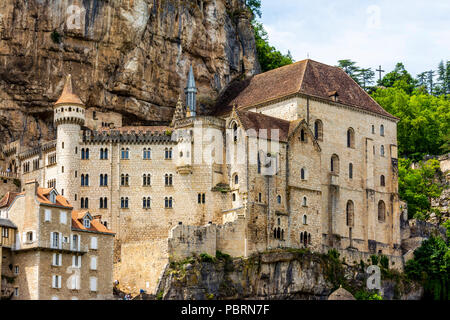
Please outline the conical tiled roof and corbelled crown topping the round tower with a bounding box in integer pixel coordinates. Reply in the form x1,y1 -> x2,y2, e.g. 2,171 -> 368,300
53,74 -> 86,126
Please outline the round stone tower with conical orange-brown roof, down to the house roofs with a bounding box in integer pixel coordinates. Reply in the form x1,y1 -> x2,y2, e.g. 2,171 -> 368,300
53,75 -> 86,209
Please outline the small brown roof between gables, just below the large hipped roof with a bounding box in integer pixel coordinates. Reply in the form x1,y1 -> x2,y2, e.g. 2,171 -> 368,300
236,110 -> 290,142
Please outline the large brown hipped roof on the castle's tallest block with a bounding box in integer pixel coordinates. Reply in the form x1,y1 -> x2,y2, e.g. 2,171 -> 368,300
215,59 -> 396,119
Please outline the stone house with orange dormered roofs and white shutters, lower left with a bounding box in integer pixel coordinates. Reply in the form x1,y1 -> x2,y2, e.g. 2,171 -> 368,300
0,180 -> 114,300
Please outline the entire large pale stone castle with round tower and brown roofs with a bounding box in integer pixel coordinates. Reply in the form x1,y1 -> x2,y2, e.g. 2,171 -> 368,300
3,59 -> 402,292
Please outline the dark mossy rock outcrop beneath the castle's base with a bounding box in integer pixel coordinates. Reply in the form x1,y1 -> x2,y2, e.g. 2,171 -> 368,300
153,249 -> 423,300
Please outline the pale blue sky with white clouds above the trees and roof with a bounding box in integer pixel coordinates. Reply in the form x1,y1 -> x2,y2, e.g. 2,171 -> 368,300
261,0 -> 450,78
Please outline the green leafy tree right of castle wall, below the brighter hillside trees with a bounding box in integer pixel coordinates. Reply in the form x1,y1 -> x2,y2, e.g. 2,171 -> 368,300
398,159 -> 443,220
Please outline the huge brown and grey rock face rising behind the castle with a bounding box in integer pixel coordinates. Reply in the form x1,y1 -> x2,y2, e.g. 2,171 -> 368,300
0,0 -> 260,144
